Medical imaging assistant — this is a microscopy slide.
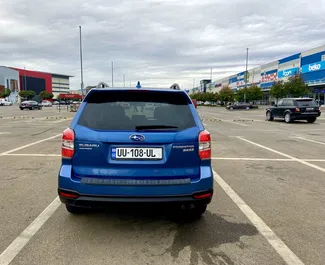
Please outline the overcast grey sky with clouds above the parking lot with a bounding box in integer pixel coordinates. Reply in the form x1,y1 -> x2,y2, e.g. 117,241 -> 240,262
0,0 -> 325,89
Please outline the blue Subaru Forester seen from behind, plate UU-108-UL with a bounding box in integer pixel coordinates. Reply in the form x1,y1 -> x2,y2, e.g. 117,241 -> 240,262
58,84 -> 213,217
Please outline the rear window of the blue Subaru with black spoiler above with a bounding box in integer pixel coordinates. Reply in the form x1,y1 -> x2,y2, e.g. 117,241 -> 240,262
78,90 -> 195,130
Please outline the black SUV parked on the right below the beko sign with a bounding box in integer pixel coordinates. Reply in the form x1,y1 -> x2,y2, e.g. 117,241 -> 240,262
266,98 -> 321,123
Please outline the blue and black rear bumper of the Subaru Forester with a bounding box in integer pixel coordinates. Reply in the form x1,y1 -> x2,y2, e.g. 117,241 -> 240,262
58,165 -> 213,207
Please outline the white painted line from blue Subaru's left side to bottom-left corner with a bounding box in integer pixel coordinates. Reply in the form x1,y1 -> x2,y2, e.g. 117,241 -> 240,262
0,197 -> 61,265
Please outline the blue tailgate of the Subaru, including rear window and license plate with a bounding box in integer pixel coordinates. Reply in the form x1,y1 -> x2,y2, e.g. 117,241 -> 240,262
72,90 -> 201,179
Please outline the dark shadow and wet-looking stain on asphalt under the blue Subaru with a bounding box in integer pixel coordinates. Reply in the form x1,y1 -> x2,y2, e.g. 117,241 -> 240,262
72,205 -> 258,265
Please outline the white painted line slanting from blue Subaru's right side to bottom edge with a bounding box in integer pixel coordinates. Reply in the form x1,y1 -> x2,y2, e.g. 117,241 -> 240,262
213,171 -> 304,265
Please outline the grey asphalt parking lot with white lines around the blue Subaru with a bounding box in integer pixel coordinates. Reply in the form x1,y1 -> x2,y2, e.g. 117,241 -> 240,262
0,106 -> 325,265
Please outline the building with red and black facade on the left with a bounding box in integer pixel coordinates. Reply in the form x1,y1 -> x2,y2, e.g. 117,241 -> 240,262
0,66 -> 73,103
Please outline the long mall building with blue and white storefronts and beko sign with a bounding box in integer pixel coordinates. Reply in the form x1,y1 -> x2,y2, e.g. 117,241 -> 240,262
190,45 -> 325,102
